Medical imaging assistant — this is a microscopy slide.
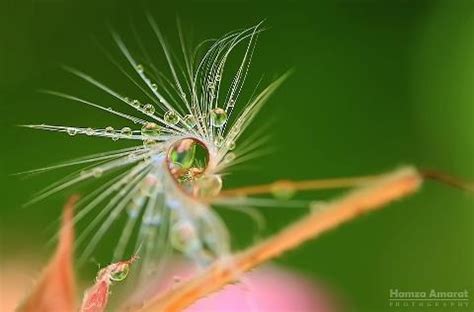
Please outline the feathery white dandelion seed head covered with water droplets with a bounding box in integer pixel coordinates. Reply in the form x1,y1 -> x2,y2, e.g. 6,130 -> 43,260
28,20 -> 285,272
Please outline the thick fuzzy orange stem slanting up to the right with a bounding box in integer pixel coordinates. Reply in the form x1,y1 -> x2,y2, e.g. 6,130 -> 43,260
140,168 -> 423,312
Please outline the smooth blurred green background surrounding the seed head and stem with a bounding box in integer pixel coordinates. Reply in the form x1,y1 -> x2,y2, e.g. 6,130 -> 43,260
0,0 -> 474,311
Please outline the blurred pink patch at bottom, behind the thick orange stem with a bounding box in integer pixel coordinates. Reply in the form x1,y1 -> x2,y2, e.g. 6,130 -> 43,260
125,264 -> 341,312
